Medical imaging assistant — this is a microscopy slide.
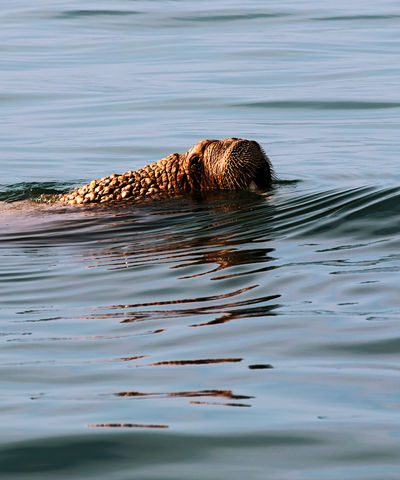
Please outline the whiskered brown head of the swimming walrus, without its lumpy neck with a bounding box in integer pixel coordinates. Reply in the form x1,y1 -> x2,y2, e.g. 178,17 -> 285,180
182,138 -> 272,191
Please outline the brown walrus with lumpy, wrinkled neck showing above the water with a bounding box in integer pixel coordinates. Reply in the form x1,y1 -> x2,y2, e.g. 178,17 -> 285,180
59,138 -> 273,205
